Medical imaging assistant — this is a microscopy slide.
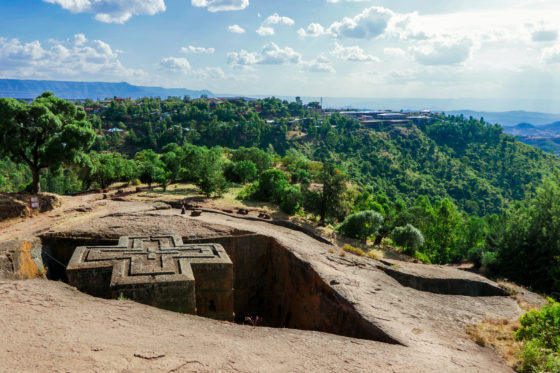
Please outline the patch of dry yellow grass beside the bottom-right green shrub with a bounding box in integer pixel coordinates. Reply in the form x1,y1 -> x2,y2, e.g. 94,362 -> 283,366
467,320 -> 523,368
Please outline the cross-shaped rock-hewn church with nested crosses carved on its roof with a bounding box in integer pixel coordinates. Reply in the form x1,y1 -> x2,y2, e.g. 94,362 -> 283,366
66,235 -> 233,320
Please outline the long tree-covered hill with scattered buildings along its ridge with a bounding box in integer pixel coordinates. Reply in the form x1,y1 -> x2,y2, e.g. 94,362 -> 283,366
4,98 -> 560,216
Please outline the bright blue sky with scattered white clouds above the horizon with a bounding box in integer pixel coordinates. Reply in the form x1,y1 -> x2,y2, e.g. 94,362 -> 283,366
0,0 -> 560,106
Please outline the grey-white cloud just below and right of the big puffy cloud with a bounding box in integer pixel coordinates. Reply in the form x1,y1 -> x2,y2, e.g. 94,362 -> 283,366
411,37 -> 474,65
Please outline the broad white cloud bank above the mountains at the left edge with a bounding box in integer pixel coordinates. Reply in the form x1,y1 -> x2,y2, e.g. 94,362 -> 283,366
0,34 -> 146,81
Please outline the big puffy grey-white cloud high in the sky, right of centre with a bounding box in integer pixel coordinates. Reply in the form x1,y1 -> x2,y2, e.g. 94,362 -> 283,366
327,6 -> 394,39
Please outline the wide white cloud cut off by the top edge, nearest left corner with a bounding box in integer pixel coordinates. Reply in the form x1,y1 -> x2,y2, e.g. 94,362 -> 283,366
43,0 -> 165,23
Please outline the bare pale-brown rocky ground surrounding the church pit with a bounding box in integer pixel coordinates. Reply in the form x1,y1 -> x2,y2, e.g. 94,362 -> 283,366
0,187 -> 542,372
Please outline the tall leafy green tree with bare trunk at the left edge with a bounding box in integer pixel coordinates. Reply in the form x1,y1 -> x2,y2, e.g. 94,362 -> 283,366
0,92 -> 95,193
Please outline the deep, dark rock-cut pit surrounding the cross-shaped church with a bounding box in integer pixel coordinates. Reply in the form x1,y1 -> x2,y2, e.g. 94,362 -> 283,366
41,234 -> 400,344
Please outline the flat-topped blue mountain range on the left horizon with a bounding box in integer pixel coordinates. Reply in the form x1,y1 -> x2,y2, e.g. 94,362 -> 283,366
0,79 -> 214,100
